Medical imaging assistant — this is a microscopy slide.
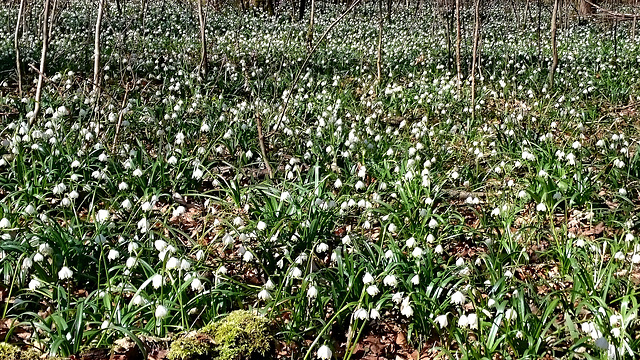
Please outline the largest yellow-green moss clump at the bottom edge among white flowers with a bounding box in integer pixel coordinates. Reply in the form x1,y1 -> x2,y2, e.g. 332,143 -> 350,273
167,310 -> 273,360
